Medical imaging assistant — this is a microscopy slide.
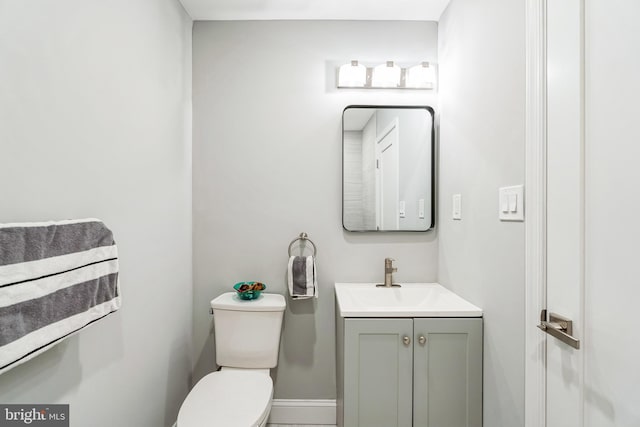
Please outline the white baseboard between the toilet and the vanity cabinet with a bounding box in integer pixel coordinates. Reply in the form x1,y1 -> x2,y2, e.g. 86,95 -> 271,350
268,399 -> 336,425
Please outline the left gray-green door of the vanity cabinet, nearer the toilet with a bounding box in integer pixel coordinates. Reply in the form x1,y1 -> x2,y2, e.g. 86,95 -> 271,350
344,319 -> 413,427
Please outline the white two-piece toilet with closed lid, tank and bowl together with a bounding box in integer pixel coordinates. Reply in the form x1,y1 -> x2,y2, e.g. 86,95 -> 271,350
176,292 -> 285,427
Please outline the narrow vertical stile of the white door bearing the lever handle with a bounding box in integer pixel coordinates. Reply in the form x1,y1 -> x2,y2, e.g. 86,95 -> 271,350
546,0 -> 584,427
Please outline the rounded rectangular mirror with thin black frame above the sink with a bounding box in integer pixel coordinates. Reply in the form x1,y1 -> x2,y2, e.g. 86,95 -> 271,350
342,105 -> 434,231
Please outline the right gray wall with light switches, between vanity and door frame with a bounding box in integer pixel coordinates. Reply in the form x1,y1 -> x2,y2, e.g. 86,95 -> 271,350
438,0 -> 525,426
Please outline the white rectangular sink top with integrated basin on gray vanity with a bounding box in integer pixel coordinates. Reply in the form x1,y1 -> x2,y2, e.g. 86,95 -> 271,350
335,283 -> 482,317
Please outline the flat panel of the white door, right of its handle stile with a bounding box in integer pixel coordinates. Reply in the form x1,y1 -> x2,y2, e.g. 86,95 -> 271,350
583,0 -> 640,427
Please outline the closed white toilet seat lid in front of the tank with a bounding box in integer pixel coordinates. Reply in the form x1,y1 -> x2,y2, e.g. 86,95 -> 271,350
177,369 -> 273,427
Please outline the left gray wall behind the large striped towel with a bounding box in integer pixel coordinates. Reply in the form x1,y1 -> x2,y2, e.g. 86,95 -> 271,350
0,0 -> 192,427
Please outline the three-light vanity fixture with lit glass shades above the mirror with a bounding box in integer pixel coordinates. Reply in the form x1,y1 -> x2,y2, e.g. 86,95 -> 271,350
337,60 -> 436,89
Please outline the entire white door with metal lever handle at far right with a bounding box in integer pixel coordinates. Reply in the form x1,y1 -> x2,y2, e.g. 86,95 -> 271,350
545,0 -> 640,427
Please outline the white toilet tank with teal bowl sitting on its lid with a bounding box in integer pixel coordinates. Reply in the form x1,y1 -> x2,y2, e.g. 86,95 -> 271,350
211,292 -> 285,368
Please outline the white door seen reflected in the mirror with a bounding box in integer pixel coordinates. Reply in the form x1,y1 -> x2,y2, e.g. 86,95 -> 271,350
376,121 -> 400,230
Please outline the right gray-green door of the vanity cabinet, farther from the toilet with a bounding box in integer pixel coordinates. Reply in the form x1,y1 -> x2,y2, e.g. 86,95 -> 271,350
413,318 -> 482,427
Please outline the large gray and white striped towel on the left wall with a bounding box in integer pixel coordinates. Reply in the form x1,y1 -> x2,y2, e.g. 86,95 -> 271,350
0,218 -> 121,374
